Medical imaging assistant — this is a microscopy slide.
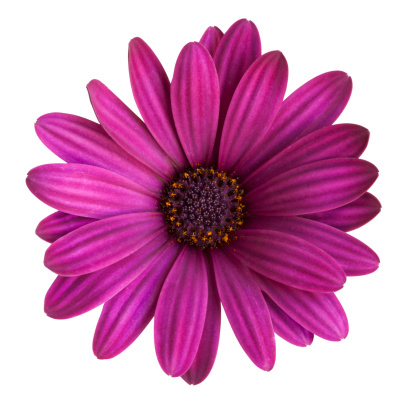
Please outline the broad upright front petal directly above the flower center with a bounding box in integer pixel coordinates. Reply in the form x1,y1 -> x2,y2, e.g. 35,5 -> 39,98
171,42 -> 220,167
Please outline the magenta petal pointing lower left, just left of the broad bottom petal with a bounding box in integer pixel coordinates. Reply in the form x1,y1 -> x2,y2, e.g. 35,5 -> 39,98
93,242 -> 180,359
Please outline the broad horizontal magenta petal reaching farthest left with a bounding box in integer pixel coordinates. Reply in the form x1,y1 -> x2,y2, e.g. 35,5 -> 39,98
26,164 -> 157,218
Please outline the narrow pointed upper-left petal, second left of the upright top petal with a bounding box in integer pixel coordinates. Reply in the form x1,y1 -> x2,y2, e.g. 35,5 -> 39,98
87,80 -> 174,180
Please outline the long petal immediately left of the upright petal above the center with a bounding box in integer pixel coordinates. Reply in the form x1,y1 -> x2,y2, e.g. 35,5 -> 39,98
128,37 -> 187,167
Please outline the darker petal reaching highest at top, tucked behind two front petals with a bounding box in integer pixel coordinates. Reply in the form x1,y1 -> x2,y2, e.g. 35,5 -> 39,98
214,19 -> 262,158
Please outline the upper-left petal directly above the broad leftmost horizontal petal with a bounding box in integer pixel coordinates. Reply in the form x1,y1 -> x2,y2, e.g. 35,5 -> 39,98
35,113 -> 163,189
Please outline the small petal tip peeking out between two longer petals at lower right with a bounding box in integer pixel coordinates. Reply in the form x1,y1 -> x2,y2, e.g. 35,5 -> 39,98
263,294 -> 313,346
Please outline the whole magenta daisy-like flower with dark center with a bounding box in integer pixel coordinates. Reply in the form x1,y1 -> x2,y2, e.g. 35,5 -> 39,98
27,20 -> 381,384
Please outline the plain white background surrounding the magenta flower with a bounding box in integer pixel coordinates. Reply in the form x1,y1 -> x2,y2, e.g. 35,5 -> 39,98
0,0 -> 414,414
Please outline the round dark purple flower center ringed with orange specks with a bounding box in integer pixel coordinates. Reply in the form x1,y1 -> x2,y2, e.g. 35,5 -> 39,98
161,168 -> 244,249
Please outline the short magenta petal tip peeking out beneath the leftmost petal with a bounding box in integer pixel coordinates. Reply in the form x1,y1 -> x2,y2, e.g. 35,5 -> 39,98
36,211 -> 96,243
